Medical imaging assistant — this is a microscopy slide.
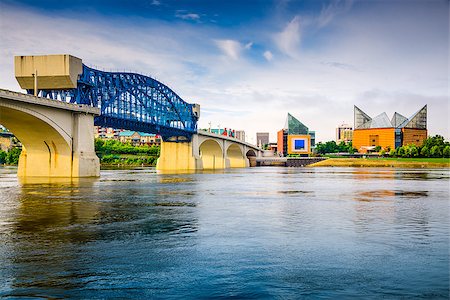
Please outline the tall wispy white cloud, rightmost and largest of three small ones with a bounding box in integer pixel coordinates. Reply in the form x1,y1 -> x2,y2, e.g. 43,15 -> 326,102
274,16 -> 301,58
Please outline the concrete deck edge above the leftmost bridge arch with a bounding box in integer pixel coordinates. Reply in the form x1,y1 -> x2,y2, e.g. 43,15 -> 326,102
0,89 -> 100,115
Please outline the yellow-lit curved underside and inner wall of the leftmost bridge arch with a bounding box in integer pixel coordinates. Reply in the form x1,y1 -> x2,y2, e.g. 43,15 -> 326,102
0,106 -> 72,177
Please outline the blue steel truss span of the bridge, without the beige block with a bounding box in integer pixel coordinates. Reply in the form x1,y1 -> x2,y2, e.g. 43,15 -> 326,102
27,64 -> 200,141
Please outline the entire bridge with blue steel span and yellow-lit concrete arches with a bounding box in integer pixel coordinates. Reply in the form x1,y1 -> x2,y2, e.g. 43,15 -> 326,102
0,55 -> 261,177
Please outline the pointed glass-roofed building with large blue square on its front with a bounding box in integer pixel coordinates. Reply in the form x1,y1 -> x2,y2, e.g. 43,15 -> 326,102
277,113 -> 316,156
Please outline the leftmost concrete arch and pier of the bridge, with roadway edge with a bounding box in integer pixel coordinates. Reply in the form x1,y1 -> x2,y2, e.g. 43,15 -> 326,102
0,90 -> 100,177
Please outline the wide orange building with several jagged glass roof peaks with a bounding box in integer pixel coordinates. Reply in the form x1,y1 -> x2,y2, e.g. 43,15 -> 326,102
353,105 -> 427,153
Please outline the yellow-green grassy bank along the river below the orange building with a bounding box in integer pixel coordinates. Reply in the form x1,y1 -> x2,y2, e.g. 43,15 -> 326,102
309,158 -> 450,168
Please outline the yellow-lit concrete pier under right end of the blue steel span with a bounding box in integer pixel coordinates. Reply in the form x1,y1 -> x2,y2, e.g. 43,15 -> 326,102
156,140 -> 201,171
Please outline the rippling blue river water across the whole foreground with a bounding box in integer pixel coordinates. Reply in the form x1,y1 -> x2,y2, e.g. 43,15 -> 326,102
0,167 -> 450,299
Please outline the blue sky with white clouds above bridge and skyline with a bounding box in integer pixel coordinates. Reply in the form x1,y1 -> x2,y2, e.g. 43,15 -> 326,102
0,0 -> 450,143
